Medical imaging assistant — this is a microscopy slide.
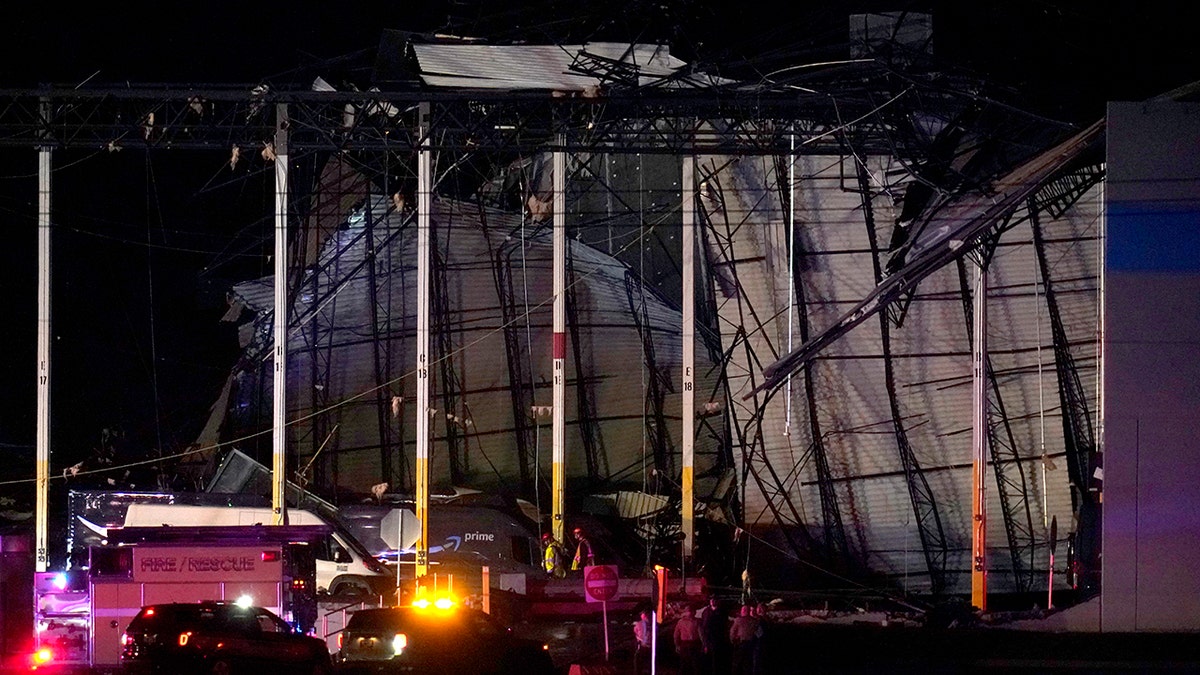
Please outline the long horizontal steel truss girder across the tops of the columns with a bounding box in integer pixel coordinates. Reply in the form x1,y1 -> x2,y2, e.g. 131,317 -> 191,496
0,70 -> 1028,156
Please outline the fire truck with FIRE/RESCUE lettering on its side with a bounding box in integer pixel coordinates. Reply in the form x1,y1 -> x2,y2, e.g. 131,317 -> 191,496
34,525 -> 330,673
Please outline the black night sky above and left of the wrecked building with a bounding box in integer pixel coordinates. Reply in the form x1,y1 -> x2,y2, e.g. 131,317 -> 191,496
0,0 -> 1200,500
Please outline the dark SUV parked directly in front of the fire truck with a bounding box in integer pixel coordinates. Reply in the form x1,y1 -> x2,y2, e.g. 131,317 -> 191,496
121,602 -> 331,675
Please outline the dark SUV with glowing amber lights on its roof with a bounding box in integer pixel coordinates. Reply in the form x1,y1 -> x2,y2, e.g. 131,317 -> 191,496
335,601 -> 554,675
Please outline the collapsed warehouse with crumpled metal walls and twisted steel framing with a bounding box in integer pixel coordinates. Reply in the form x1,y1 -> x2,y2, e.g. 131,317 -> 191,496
4,17 -> 1104,605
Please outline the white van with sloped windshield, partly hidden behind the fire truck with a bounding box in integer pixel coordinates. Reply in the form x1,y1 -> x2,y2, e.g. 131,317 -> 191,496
125,503 -> 396,596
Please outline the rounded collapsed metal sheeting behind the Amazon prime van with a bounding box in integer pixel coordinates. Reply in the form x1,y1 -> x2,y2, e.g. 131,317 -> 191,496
234,186 -> 719,506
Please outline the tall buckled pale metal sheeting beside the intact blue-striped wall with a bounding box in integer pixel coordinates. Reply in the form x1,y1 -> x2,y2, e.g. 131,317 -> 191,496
702,148 -> 1102,593
